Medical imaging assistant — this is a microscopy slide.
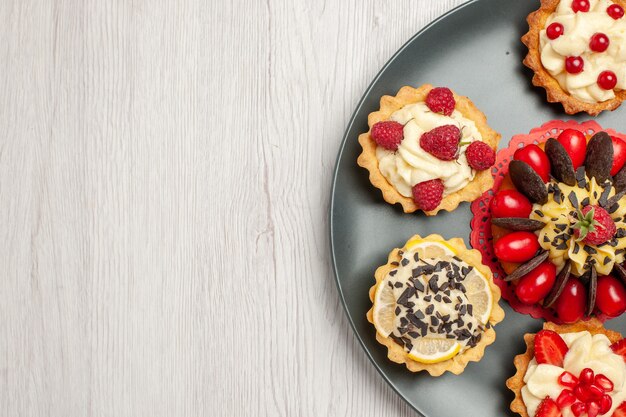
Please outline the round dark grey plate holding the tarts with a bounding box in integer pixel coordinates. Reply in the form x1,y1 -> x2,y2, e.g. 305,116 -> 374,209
330,0 -> 626,417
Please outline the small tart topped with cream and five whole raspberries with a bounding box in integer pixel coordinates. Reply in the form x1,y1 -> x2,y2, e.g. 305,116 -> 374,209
358,84 -> 500,215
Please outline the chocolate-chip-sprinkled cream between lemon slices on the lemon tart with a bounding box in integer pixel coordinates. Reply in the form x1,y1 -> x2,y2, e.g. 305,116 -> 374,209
388,243 -> 487,352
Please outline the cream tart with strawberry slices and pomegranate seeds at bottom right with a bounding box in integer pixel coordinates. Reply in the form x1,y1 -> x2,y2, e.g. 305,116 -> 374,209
506,319 -> 626,417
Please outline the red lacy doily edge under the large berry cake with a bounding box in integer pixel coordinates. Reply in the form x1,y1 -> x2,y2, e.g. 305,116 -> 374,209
470,120 -> 626,323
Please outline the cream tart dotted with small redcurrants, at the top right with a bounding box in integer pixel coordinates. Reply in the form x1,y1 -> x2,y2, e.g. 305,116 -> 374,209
522,0 -> 626,116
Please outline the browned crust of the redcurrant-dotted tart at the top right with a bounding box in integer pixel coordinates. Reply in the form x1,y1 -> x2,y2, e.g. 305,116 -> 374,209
522,0 -> 626,116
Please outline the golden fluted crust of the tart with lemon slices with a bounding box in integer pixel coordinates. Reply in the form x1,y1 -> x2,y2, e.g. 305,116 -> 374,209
367,234 -> 504,376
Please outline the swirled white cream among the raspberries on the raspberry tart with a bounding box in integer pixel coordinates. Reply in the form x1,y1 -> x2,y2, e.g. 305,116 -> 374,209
376,103 -> 482,197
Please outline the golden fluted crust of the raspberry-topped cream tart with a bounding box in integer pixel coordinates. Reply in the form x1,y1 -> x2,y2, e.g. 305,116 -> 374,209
357,84 -> 500,216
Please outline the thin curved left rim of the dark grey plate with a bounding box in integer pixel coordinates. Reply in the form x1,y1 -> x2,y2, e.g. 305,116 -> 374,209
328,0 -> 481,417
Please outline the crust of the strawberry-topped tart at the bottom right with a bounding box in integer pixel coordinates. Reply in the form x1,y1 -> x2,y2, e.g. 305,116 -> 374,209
506,319 -> 622,417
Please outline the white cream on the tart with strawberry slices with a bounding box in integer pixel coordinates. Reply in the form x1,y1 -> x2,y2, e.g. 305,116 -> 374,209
522,331 -> 626,417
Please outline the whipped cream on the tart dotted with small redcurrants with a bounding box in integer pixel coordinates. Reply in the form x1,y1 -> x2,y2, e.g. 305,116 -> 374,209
539,0 -> 626,103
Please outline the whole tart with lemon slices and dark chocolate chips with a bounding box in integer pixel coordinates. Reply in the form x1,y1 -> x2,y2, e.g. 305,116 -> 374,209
367,235 -> 504,376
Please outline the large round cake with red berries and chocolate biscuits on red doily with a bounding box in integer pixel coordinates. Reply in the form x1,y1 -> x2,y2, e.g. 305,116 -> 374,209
472,122 -> 626,323
